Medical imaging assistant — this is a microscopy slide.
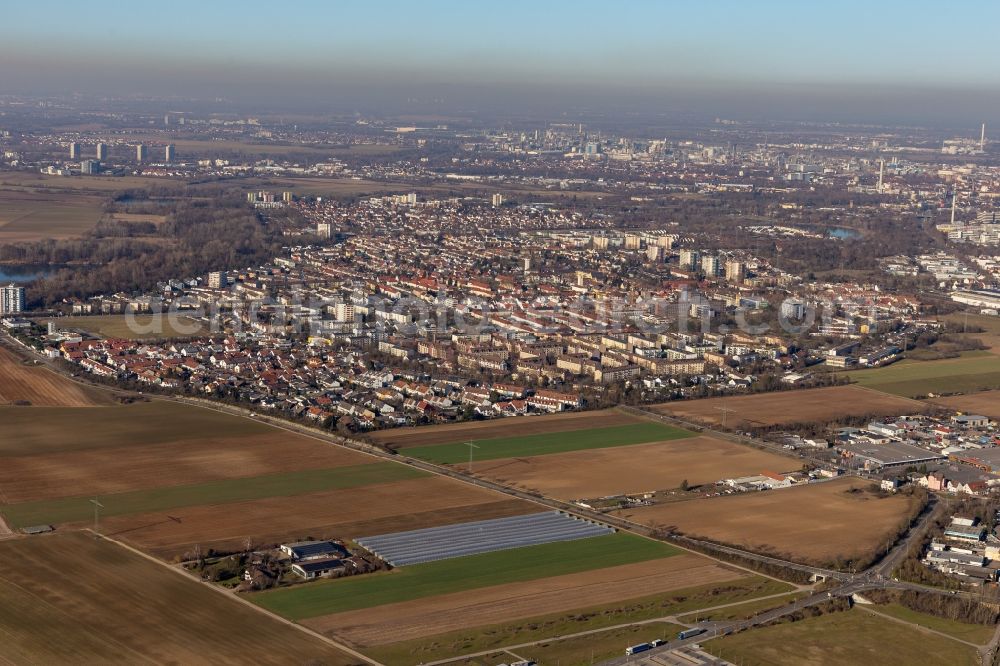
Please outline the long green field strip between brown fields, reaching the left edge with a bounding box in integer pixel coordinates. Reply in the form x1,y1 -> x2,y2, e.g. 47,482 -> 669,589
0,462 -> 429,527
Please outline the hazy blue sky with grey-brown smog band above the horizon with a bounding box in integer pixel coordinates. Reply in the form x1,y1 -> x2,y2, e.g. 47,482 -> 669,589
0,0 -> 1000,120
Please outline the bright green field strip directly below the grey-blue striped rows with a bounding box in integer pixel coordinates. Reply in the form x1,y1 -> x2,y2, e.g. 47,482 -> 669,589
258,533 -> 680,620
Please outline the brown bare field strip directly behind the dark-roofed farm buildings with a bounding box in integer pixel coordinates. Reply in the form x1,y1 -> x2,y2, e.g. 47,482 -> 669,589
101,476 -> 538,559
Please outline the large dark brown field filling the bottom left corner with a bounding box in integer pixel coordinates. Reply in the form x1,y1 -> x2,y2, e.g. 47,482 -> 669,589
0,532 -> 358,666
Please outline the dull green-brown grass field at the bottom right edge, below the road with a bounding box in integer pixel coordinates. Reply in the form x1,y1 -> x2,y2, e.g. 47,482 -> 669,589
703,609 -> 980,666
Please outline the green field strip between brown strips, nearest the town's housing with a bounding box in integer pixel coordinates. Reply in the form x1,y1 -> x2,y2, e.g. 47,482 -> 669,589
406,422 -> 694,464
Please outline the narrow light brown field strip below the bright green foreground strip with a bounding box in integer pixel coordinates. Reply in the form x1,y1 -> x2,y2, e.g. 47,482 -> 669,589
304,554 -> 746,647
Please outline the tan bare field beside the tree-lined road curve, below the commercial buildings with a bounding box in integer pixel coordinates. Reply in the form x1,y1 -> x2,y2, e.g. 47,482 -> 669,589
616,478 -> 915,564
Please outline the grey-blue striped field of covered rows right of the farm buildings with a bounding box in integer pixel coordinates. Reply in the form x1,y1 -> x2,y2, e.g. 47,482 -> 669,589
357,511 -> 614,567
